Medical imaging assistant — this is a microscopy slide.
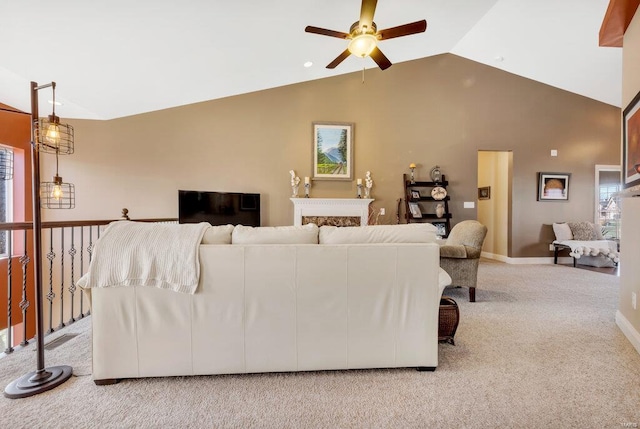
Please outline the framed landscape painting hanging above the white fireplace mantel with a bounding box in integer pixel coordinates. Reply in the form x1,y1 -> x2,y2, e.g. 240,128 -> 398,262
311,122 -> 355,180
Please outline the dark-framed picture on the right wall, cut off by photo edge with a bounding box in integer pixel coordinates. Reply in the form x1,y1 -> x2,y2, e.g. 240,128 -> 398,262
622,92 -> 640,188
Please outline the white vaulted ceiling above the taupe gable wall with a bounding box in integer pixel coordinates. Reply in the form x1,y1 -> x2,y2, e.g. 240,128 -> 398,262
0,0 -> 622,119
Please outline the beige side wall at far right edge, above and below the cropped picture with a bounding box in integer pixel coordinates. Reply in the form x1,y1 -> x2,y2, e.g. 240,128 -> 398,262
619,9 -> 640,344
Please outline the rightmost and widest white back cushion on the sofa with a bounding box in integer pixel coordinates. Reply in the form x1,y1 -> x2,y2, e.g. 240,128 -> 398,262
319,223 -> 437,244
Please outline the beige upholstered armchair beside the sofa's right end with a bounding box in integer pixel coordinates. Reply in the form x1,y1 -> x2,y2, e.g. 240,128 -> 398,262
440,220 -> 487,302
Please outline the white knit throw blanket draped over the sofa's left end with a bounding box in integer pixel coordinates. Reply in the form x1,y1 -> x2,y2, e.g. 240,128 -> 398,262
78,221 -> 211,294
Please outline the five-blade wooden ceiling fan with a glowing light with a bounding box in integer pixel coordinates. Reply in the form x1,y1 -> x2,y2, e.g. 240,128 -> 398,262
304,0 -> 427,70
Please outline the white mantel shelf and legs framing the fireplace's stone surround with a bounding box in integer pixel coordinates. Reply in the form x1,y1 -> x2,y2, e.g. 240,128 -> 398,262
291,198 -> 373,226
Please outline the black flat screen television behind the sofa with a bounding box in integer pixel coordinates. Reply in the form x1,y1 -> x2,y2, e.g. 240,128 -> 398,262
178,191 -> 260,226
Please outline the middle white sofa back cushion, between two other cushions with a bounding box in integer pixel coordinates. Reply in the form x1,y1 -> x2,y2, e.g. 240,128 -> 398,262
231,223 -> 318,244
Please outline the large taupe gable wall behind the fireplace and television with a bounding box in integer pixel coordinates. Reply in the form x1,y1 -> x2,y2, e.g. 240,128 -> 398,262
44,54 -> 620,257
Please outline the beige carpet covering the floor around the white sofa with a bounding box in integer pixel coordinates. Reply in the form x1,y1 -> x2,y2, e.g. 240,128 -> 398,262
0,262 -> 640,428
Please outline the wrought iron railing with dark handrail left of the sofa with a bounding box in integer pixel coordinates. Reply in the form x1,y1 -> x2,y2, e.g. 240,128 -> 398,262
0,209 -> 177,354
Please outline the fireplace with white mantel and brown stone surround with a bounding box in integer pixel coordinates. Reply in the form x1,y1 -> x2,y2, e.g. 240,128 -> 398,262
291,198 -> 373,226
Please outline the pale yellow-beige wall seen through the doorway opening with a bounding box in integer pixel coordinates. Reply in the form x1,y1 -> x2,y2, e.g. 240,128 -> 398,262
478,151 -> 512,259
